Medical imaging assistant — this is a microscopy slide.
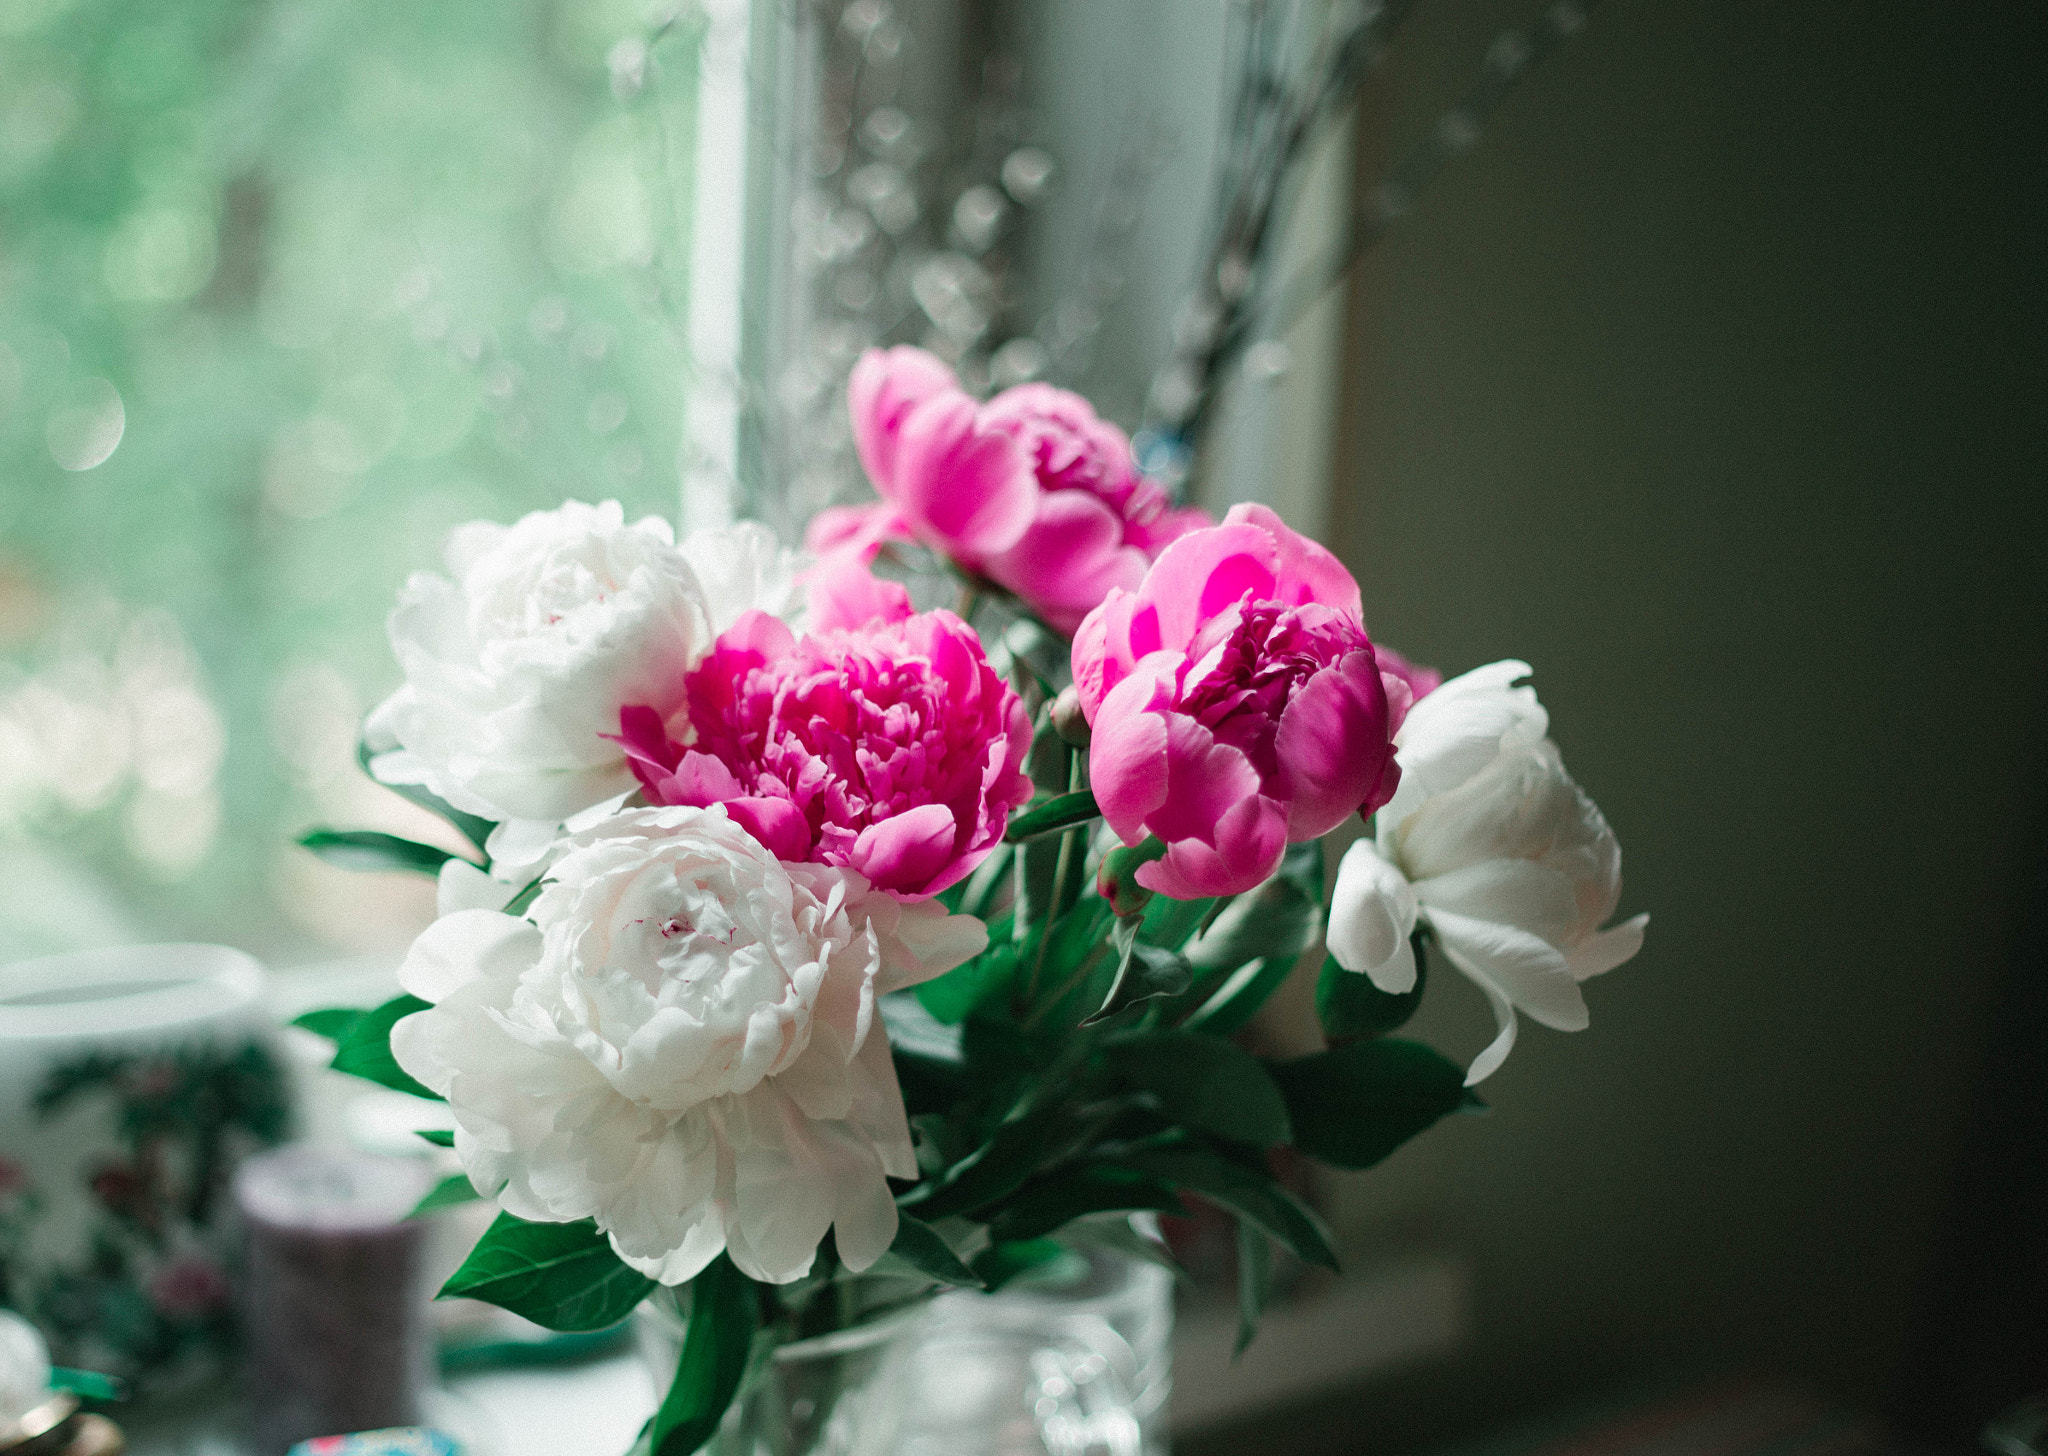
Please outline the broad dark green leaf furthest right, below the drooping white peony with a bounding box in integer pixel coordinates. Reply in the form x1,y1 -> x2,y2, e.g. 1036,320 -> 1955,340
1268,1036 -> 1485,1167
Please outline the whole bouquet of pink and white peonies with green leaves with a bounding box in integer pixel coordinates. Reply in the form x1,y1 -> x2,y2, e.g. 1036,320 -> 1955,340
305,348 -> 1645,1456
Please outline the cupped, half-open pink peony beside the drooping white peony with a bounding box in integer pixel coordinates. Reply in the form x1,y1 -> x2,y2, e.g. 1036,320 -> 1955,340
1073,506 -> 1409,899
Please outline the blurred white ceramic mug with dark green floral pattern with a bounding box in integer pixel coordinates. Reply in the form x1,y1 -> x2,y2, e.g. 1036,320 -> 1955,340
0,946 -> 291,1390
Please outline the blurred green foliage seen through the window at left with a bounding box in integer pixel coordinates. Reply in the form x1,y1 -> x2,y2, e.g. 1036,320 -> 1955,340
0,0 -> 696,954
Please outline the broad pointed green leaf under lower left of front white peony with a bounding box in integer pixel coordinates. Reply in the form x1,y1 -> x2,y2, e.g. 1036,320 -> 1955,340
440,1212 -> 655,1333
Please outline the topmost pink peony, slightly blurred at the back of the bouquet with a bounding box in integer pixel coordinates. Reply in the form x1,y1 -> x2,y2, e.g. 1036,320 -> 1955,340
807,346 -> 1212,633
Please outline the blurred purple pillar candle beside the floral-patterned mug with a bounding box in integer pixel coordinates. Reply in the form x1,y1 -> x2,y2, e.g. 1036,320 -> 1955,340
236,1145 -> 432,1456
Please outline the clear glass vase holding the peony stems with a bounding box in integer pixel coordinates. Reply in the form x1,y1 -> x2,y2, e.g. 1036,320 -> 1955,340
637,1249 -> 1174,1456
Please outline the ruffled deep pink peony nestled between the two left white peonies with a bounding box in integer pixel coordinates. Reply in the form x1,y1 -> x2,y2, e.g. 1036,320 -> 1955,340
618,592 -> 1030,899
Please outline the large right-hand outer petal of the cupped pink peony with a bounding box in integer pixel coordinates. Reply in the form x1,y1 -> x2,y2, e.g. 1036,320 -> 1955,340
1274,651 -> 1395,844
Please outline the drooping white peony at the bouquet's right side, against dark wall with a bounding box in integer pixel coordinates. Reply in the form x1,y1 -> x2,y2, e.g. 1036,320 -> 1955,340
1329,661 -> 1649,1085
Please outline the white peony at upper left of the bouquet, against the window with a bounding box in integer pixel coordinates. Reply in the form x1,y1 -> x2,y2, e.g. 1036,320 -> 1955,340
365,502 -> 803,876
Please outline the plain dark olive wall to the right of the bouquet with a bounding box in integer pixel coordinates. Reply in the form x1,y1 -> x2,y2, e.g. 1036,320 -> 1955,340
1333,0 -> 2048,1433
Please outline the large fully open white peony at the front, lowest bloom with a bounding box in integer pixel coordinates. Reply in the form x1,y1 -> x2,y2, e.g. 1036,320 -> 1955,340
391,807 -> 987,1284
